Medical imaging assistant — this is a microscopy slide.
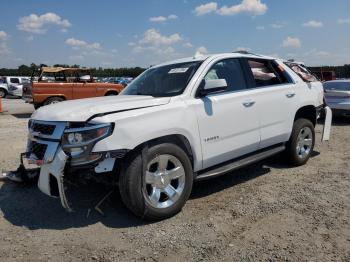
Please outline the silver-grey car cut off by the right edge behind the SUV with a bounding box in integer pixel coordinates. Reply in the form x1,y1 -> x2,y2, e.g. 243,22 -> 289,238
323,79 -> 350,116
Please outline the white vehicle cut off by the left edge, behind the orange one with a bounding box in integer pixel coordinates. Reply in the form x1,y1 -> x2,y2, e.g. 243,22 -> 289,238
0,76 -> 29,98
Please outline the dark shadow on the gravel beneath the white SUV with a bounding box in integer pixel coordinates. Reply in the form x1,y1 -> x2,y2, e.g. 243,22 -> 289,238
0,152 -> 319,230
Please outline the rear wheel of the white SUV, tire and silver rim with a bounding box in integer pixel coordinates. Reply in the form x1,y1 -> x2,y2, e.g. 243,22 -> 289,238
286,118 -> 315,166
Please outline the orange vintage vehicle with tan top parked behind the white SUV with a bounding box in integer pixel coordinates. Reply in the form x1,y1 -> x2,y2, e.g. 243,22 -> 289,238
23,67 -> 124,109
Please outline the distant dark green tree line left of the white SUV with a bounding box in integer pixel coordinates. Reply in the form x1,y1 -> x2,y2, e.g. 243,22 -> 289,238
0,63 -> 145,77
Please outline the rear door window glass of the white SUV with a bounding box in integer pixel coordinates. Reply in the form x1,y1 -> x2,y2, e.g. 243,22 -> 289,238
248,59 -> 290,87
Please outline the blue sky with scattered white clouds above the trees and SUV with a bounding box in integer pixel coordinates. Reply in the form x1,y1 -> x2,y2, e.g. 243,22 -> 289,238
0,0 -> 350,68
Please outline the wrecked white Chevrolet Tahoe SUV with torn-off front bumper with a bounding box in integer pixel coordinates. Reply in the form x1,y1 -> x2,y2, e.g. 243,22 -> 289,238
24,53 -> 331,220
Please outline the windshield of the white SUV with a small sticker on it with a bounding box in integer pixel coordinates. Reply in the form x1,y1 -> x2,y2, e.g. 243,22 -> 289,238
122,61 -> 202,97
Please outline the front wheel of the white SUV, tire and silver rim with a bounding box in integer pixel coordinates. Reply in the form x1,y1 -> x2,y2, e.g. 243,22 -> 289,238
119,143 -> 193,220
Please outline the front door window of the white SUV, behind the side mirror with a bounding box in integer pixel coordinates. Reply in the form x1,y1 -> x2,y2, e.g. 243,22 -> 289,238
204,59 -> 246,91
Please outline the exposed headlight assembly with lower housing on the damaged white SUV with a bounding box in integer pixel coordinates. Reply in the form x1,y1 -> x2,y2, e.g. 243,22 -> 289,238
62,124 -> 113,166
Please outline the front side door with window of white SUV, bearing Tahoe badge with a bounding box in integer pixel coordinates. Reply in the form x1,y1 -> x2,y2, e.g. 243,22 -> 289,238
192,58 -> 260,168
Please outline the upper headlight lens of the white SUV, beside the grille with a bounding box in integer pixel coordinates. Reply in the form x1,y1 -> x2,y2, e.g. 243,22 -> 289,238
62,124 -> 112,147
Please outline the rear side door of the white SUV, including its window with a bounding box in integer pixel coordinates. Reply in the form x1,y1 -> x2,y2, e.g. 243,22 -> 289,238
245,59 -> 299,149
